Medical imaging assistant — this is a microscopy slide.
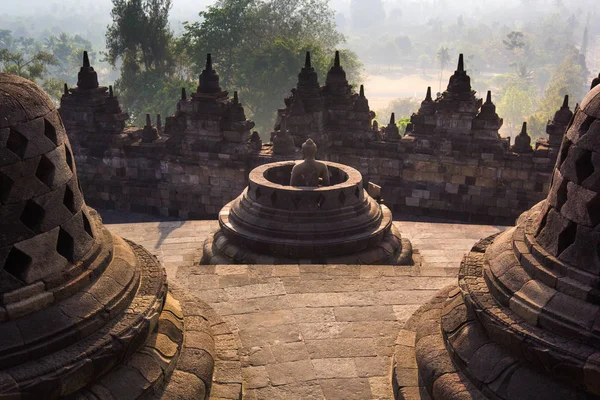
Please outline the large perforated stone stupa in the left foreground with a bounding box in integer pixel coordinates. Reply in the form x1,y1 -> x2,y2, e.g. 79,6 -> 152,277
0,74 -> 213,399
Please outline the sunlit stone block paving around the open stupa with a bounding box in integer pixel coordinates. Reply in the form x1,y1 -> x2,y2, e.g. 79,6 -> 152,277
101,212 -> 503,399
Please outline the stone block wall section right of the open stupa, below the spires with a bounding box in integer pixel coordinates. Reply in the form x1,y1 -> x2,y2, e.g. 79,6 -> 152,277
329,144 -> 553,225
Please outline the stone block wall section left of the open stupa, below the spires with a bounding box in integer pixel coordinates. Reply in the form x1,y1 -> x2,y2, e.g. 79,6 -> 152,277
75,143 -> 250,219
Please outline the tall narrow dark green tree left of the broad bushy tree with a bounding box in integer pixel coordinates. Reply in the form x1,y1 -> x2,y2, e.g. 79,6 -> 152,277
105,0 -> 193,126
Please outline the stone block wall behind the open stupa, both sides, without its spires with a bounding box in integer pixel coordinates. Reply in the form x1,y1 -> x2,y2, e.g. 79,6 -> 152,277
69,133 -> 553,224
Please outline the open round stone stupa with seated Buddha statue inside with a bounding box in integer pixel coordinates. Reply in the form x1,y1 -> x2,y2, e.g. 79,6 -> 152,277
201,141 -> 413,265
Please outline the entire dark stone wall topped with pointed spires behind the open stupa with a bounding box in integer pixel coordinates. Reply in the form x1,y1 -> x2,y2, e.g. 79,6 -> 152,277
60,54 -> 572,224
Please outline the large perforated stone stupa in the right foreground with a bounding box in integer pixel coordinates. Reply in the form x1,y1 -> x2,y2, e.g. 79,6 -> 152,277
394,83 -> 600,400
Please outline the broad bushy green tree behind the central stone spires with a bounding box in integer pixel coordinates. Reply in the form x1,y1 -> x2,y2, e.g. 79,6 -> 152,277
184,0 -> 360,134
